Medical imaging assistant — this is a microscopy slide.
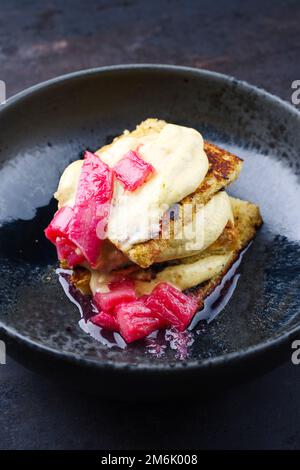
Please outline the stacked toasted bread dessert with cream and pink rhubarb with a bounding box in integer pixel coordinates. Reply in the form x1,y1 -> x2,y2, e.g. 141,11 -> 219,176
45,119 -> 262,343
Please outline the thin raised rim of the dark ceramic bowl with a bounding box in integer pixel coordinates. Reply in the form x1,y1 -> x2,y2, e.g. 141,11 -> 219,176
0,63 -> 300,373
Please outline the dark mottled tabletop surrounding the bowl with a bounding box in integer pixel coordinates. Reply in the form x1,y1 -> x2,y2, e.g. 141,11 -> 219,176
0,0 -> 300,449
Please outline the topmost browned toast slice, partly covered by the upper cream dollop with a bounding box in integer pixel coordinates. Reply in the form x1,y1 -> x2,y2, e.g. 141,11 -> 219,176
97,119 -> 243,268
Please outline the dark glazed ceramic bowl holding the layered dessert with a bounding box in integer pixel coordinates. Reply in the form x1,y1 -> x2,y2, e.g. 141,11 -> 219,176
0,65 -> 300,398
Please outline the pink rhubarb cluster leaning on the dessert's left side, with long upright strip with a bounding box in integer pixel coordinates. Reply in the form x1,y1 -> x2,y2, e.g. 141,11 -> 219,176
45,151 -> 113,268
